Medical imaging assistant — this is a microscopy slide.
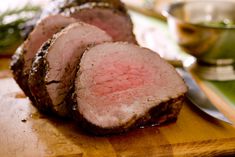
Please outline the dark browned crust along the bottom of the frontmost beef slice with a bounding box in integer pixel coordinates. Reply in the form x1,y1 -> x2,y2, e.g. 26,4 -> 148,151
69,87 -> 185,136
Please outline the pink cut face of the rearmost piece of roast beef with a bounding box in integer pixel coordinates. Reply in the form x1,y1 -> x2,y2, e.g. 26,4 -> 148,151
72,8 -> 134,42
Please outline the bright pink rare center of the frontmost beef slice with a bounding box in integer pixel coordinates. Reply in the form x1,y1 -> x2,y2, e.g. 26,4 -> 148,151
91,61 -> 150,96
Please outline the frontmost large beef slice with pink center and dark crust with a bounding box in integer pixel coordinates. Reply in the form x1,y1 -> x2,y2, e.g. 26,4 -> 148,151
71,43 -> 187,135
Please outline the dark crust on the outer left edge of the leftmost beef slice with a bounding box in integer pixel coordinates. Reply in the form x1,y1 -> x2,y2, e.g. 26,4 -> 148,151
10,45 -> 35,103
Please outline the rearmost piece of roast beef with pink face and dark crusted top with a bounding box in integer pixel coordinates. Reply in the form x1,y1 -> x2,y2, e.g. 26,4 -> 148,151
64,3 -> 137,43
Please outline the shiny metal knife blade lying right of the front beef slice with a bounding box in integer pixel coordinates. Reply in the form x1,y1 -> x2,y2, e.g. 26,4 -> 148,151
177,68 -> 232,124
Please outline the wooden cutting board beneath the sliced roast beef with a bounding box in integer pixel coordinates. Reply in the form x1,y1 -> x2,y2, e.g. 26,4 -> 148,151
0,71 -> 235,157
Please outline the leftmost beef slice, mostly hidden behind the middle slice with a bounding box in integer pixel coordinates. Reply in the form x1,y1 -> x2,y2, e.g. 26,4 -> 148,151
11,15 -> 77,101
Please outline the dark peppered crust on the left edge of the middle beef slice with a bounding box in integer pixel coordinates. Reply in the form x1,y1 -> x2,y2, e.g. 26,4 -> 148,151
28,30 -> 69,117
